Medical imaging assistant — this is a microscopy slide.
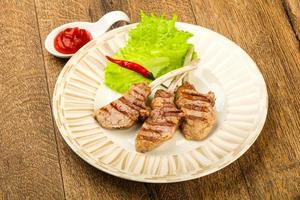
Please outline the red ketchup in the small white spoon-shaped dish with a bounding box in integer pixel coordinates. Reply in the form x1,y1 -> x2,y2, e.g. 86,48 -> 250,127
54,27 -> 93,54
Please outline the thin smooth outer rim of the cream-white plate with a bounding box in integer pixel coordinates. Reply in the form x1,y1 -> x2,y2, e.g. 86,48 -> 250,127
52,22 -> 268,183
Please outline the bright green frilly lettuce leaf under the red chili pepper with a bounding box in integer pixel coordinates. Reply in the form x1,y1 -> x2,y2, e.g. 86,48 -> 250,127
105,12 -> 192,93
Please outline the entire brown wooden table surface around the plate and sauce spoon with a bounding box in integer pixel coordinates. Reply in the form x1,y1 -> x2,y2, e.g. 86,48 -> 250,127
0,0 -> 300,199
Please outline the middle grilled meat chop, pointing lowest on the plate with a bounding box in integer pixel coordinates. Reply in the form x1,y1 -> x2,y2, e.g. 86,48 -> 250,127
135,90 -> 182,152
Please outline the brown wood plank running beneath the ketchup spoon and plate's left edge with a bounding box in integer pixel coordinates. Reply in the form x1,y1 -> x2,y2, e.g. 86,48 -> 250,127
36,0 -> 148,200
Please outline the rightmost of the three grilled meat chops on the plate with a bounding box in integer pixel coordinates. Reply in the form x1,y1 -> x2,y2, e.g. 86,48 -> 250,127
175,82 -> 216,140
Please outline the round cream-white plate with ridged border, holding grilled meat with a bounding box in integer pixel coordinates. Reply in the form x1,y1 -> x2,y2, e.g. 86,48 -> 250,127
53,23 -> 267,183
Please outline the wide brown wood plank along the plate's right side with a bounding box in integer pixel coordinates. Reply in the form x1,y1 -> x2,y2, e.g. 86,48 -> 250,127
192,0 -> 300,199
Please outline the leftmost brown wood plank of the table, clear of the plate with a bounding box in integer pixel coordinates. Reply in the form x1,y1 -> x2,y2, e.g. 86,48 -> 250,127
0,0 -> 64,199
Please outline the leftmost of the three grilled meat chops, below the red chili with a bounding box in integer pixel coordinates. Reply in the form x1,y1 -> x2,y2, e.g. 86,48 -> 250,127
94,83 -> 151,129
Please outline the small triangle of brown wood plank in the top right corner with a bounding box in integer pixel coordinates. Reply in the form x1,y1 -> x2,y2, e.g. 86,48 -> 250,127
282,0 -> 300,42
